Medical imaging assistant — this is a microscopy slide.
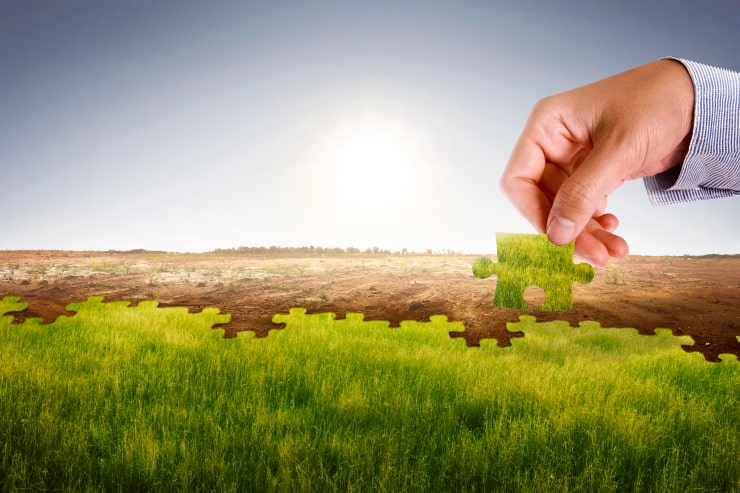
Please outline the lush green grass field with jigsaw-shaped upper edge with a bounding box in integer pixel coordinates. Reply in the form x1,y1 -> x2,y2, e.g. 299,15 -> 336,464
0,298 -> 740,492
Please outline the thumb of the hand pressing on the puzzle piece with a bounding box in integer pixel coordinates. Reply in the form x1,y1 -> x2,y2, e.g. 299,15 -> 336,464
547,146 -> 627,245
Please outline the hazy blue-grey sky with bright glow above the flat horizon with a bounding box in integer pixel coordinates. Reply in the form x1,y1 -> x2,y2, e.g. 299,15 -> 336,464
0,0 -> 740,255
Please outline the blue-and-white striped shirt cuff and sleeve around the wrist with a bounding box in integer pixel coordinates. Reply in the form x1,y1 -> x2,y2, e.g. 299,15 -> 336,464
643,58 -> 740,205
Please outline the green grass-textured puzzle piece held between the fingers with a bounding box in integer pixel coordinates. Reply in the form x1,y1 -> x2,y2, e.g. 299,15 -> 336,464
473,233 -> 594,311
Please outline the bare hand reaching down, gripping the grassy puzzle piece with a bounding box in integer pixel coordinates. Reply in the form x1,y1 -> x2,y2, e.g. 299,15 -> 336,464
501,60 -> 694,267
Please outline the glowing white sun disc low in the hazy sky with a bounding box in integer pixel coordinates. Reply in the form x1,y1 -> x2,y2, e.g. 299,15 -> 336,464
334,134 -> 413,214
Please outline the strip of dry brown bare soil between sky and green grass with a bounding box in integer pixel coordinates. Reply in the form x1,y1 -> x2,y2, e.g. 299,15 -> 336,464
0,251 -> 740,361
